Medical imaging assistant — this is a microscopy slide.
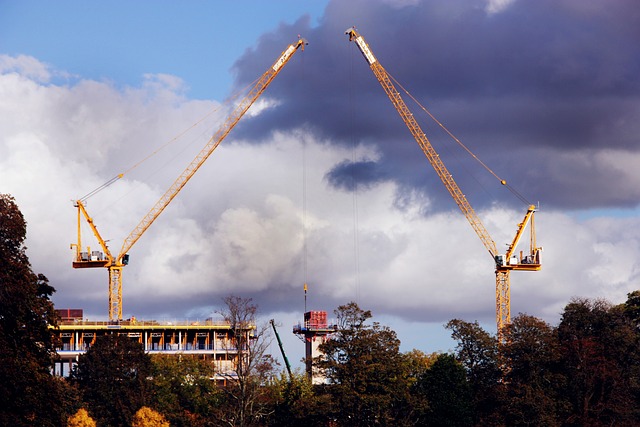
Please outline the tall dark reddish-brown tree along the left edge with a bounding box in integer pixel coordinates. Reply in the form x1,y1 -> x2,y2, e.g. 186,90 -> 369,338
0,194 -> 72,427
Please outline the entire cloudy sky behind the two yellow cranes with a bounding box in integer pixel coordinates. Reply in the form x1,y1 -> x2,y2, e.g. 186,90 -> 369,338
0,0 -> 640,372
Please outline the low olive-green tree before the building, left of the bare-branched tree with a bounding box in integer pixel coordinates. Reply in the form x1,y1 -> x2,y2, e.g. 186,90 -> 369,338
151,355 -> 222,427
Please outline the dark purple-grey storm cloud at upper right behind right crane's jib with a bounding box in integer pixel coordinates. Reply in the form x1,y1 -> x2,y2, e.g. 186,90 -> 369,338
228,0 -> 640,208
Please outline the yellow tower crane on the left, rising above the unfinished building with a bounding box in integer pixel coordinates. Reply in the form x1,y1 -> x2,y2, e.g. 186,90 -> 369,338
71,36 -> 308,321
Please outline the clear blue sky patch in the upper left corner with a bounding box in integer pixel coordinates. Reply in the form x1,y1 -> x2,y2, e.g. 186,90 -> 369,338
0,0 -> 327,99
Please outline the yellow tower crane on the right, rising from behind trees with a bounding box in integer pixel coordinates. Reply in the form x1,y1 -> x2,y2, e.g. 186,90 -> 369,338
345,27 -> 542,341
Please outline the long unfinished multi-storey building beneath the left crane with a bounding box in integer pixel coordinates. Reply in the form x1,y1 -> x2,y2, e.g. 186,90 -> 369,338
54,309 -> 256,384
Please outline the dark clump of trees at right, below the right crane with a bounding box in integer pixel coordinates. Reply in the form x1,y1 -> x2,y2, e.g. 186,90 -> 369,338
449,298 -> 640,426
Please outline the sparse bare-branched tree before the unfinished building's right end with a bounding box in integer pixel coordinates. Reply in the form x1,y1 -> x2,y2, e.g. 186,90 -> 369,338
218,295 -> 276,426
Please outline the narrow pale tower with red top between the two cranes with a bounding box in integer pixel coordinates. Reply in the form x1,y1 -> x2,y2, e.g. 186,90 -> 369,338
293,311 -> 337,384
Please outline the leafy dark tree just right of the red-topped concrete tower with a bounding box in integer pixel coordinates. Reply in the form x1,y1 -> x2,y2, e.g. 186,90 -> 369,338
314,302 -> 408,426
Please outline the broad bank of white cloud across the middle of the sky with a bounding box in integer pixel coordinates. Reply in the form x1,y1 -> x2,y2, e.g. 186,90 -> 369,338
0,55 -> 640,348
